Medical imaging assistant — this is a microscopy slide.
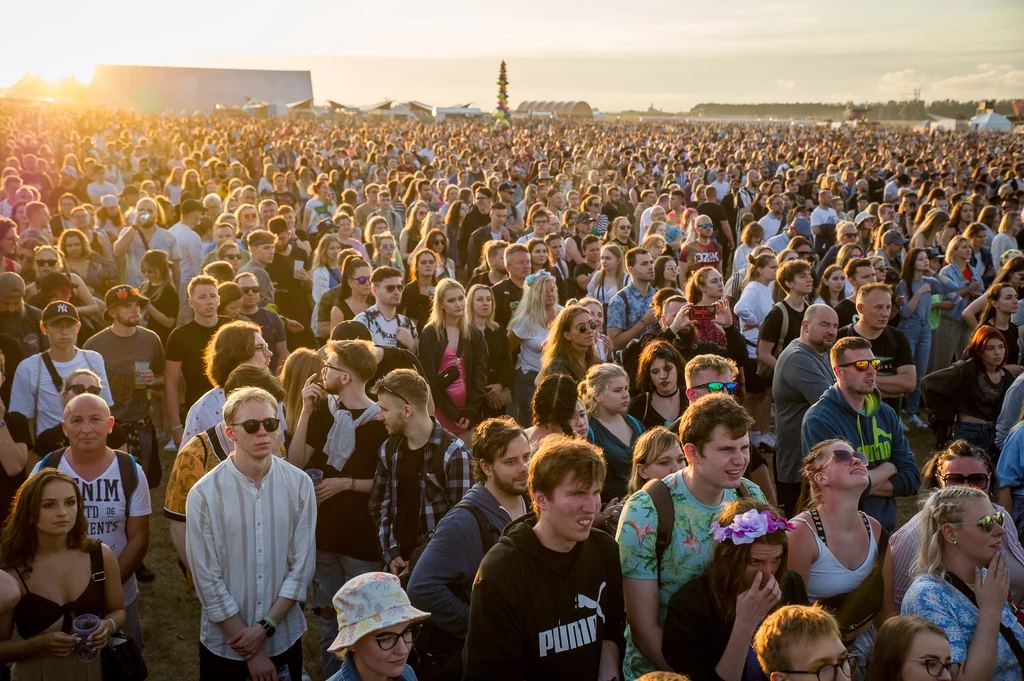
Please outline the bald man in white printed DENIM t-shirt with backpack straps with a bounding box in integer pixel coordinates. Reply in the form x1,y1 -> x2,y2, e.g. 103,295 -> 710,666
32,392 -> 152,647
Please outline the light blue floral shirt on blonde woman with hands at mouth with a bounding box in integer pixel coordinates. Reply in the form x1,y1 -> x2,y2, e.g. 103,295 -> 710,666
900,574 -> 1024,681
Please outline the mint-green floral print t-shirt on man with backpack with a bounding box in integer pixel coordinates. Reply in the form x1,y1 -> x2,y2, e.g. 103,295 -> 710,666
615,471 -> 766,681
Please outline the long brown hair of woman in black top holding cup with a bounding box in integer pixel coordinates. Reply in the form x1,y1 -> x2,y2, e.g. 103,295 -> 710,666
0,468 -> 99,576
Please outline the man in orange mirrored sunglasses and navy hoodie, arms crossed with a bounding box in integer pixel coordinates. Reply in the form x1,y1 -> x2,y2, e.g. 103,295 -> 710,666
801,337 -> 921,531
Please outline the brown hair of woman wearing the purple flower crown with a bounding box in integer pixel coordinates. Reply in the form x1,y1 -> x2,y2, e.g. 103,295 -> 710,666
708,499 -> 790,622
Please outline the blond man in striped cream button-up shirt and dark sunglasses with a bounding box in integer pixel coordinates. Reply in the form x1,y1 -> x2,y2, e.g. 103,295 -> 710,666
185,388 -> 316,681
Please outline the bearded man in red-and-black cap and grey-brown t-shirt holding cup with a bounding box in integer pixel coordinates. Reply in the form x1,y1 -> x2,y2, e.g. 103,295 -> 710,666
84,285 -> 164,487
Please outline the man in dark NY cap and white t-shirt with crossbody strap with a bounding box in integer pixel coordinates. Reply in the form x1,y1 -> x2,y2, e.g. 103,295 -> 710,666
10,300 -> 114,435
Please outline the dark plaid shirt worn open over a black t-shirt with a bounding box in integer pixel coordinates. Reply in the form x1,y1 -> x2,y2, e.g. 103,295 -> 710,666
370,417 -> 473,567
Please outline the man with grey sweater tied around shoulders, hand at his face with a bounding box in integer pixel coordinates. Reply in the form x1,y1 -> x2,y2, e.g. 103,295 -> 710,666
288,340 -> 387,679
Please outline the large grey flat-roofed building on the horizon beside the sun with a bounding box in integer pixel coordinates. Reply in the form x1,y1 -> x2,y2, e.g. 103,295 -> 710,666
88,65 -> 313,114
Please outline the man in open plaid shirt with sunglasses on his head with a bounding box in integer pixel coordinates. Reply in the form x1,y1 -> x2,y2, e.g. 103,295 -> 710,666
370,369 -> 472,577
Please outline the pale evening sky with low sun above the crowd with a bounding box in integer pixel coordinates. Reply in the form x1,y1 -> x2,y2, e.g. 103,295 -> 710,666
0,0 -> 1024,112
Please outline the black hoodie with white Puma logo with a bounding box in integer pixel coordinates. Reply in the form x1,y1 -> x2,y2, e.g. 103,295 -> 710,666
463,514 -> 626,681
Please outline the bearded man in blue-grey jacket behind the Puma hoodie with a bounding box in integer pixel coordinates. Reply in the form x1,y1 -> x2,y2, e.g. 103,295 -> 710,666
409,416 -> 530,678
